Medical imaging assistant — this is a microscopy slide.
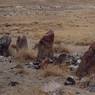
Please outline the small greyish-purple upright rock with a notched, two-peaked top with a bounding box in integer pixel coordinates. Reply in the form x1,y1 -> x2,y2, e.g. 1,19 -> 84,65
16,36 -> 28,51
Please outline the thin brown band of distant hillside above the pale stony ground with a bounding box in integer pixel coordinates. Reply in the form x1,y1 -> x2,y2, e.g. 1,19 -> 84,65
0,0 -> 95,5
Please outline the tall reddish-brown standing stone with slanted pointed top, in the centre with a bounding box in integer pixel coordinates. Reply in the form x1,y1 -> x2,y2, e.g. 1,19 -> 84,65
38,30 -> 54,60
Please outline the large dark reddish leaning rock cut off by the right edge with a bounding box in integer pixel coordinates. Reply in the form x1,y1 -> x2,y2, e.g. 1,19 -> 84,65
76,42 -> 95,78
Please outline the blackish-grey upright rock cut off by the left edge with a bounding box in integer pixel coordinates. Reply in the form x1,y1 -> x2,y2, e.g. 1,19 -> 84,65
0,35 -> 11,56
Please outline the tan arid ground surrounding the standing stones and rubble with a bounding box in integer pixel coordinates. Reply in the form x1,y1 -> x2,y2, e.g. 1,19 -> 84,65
0,0 -> 95,95
